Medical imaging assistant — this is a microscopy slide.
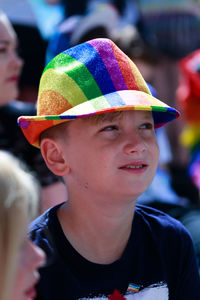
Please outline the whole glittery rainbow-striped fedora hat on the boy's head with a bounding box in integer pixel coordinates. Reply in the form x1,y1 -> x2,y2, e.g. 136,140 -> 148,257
18,39 -> 179,147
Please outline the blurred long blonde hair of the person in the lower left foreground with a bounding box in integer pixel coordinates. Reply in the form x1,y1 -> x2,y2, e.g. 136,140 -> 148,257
0,151 -> 39,300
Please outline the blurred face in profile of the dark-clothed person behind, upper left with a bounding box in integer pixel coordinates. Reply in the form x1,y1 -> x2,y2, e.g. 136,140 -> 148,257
0,13 -> 23,105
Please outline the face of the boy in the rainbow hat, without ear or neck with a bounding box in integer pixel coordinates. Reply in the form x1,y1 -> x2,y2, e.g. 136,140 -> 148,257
58,111 -> 159,199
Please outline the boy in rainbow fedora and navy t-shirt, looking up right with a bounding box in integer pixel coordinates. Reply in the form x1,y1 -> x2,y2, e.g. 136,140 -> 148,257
19,39 -> 200,300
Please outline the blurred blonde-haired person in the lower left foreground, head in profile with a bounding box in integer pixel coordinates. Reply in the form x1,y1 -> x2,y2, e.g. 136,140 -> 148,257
0,150 -> 45,300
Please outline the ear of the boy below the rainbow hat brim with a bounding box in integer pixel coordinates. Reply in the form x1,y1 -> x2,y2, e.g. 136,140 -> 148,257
40,138 -> 70,176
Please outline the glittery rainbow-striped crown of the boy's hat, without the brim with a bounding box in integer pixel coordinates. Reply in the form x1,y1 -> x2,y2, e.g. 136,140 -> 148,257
37,39 -> 151,115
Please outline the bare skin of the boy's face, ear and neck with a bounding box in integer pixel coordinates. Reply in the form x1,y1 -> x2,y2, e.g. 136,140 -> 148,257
41,111 -> 159,263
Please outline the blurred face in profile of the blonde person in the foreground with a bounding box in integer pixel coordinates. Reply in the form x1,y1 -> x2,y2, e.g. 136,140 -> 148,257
10,225 -> 45,300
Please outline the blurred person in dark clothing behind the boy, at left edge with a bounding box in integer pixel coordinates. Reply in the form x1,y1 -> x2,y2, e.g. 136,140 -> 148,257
0,11 -> 67,212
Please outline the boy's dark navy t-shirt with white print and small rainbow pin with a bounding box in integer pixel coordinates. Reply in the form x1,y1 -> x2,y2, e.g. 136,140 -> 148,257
30,205 -> 200,300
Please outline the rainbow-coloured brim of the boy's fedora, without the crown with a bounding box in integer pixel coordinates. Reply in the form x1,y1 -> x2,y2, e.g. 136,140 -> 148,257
18,90 -> 180,148
